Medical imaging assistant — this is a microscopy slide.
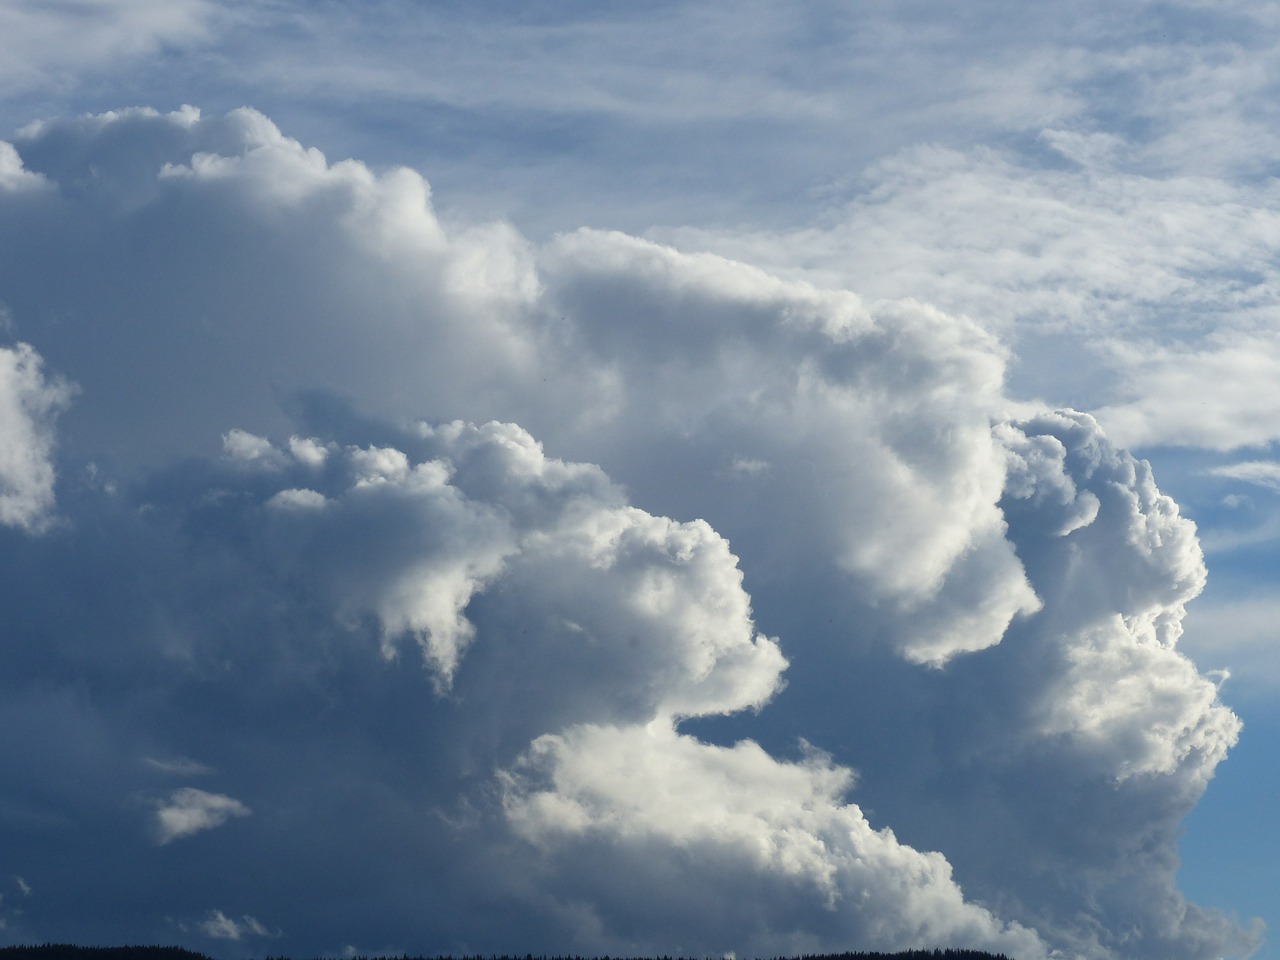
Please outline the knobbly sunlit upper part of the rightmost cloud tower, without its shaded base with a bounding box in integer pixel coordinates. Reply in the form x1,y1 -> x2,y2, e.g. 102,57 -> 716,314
1007,415 -> 1223,781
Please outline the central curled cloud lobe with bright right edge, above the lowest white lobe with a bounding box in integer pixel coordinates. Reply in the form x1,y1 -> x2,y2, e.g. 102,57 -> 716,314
225,422 -> 786,721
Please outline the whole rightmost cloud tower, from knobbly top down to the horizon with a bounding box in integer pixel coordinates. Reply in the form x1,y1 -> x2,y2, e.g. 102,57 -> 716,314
902,412 -> 1251,956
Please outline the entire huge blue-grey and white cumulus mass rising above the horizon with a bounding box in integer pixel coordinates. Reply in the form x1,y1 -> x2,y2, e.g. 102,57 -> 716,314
0,108 -> 1254,960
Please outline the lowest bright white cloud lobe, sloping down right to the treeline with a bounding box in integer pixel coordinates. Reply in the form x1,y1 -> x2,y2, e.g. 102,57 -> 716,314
504,722 -> 1046,957
